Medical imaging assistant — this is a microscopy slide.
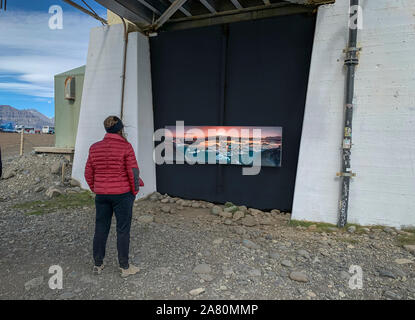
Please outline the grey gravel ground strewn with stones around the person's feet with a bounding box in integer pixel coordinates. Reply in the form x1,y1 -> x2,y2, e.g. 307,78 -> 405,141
0,155 -> 415,300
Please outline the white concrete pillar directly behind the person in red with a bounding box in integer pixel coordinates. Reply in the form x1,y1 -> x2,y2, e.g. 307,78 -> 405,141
72,25 -> 156,196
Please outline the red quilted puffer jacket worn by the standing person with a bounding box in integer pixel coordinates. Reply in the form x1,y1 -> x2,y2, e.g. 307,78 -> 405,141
85,133 -> 140,195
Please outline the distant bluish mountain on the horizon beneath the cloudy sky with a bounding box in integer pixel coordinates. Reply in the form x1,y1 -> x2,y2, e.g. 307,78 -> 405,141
0,105 -> 54,129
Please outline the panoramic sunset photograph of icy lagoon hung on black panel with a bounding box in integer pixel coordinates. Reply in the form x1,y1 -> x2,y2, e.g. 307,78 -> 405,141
165,126 -> 282,167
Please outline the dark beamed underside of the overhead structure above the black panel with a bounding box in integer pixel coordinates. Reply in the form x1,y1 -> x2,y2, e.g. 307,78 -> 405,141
95,0 -> 335,34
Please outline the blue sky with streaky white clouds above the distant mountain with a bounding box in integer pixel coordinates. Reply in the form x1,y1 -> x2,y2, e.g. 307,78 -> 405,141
0,0 -> 106,117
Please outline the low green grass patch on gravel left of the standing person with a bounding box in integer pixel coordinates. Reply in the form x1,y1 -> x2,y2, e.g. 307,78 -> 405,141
14,191 -> 94,215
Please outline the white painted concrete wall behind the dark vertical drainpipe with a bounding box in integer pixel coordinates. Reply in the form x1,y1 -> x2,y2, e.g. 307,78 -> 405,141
292,0 -> 415,227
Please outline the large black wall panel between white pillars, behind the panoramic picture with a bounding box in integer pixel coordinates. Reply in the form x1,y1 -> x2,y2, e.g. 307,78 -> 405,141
150,15 -> 315,210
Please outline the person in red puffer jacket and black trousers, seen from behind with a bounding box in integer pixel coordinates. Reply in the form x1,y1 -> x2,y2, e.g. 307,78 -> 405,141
85,116 -> 143,277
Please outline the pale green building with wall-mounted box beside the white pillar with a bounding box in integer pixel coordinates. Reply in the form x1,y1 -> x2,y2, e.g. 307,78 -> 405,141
55,66 -> 85,148
